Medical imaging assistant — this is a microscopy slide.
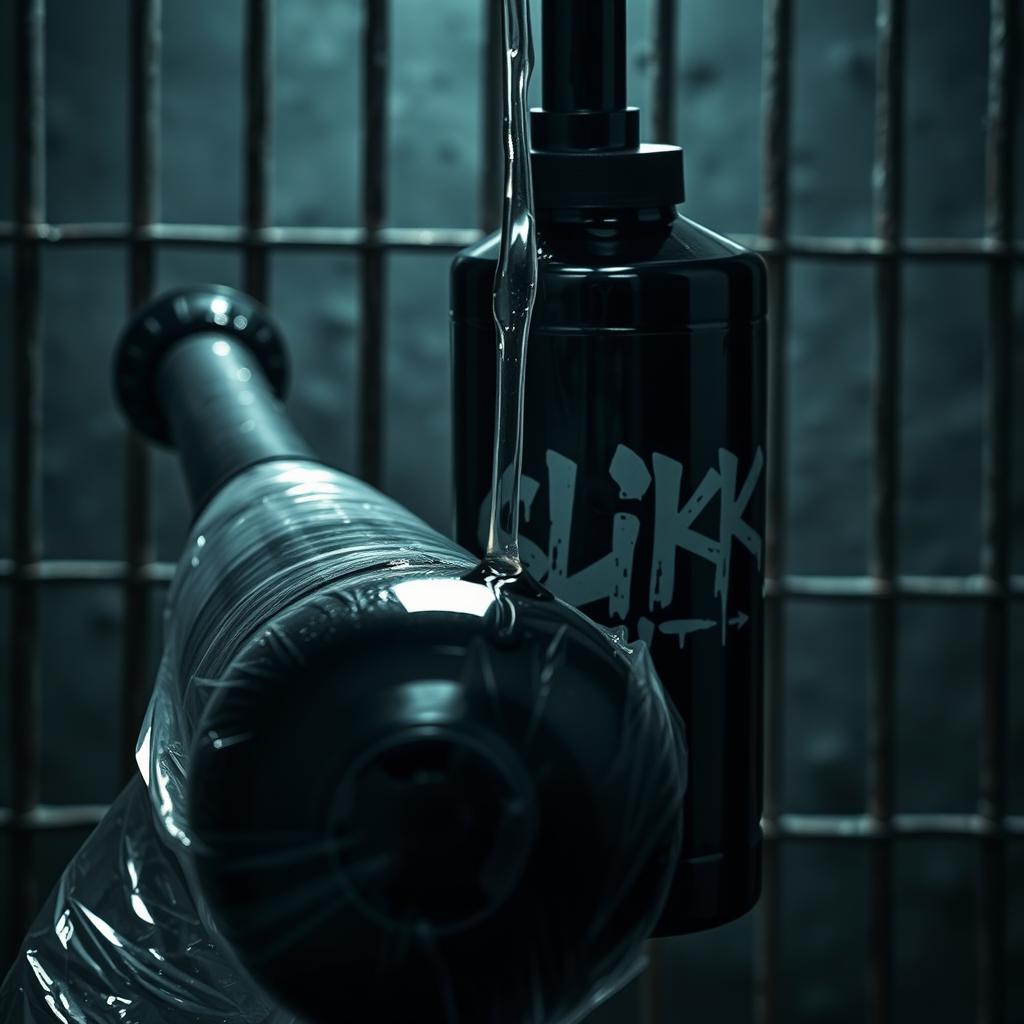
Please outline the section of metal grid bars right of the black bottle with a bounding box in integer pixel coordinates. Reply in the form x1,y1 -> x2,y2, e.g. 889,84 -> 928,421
750,0 -> 1024,1024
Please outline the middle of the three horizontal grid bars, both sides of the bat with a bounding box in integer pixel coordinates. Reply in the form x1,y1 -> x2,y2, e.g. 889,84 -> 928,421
0,558 -> 1024,601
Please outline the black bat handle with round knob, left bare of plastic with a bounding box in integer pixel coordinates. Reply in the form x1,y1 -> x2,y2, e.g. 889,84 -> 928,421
115,286 -> 315,512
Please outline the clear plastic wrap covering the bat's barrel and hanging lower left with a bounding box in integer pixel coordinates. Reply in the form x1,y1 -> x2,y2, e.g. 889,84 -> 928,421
0,461 -> 686,1024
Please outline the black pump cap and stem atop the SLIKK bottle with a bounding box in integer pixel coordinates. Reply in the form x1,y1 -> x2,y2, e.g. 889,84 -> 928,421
530,0 -> 684,209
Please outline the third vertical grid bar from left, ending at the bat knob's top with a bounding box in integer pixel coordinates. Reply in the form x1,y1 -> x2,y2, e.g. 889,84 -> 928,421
244,0 -> 273,302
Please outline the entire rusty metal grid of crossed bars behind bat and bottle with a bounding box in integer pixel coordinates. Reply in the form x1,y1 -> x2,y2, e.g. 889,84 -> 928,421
0,0 -> 1024,1024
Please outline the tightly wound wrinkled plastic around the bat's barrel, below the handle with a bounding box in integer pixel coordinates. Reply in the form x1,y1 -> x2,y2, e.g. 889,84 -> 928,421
139,461 -> 473,846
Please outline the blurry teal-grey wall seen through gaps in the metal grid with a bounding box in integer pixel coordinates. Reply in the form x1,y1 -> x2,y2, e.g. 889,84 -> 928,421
0,0 -> 1024,1024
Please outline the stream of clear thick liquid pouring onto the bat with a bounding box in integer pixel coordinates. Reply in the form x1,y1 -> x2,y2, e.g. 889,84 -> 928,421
484,0 -> 537,579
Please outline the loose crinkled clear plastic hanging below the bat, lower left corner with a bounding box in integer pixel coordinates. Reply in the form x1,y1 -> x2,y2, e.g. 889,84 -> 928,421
0,779 -> 295,1024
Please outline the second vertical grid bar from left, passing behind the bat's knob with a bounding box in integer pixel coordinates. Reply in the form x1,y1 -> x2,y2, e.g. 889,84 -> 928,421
121,0 -> 162,777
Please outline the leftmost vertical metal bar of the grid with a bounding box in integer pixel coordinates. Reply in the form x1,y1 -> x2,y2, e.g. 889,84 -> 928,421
6,0 -> 46,957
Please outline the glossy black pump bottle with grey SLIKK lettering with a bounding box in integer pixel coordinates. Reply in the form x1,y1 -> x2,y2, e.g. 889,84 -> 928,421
452,0 -> 765,935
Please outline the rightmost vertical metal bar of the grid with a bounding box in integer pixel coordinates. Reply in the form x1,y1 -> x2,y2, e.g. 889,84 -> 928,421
977,0 -> 1019,1024
